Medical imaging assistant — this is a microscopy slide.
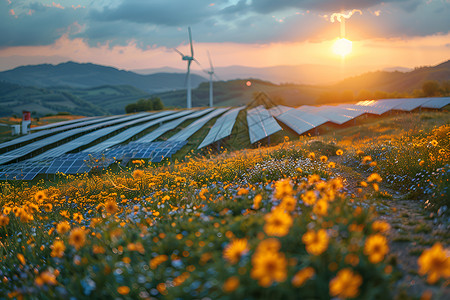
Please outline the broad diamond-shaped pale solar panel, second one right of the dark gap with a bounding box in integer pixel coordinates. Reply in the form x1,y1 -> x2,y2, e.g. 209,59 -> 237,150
276,109 -> 328,135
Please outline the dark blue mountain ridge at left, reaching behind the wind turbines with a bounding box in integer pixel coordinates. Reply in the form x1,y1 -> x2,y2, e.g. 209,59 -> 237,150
0,62 -> 206,93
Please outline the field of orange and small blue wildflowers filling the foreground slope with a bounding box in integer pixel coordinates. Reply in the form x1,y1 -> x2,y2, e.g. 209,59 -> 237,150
0,112 -> 450,299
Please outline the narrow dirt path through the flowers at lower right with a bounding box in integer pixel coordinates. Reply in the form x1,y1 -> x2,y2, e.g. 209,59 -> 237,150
337,163 -> 450,300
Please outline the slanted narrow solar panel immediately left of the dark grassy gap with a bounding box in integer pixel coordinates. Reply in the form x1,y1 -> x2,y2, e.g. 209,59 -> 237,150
198,107 -> 244,149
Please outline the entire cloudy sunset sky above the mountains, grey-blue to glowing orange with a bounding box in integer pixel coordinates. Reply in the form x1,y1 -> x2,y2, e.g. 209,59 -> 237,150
0,0 -> 450,75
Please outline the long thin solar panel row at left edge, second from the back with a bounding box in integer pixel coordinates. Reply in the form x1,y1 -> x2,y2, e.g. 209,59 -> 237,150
0,113 -> 151,164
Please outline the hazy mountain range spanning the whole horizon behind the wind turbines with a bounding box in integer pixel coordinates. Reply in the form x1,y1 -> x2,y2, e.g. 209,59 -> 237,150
0,61 -> 450,116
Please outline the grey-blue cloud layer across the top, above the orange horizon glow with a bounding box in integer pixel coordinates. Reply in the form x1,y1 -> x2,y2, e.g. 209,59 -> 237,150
0,0 -> 450,49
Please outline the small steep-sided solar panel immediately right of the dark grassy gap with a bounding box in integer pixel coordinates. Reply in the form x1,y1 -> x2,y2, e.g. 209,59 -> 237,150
247,105 -> 283,144
